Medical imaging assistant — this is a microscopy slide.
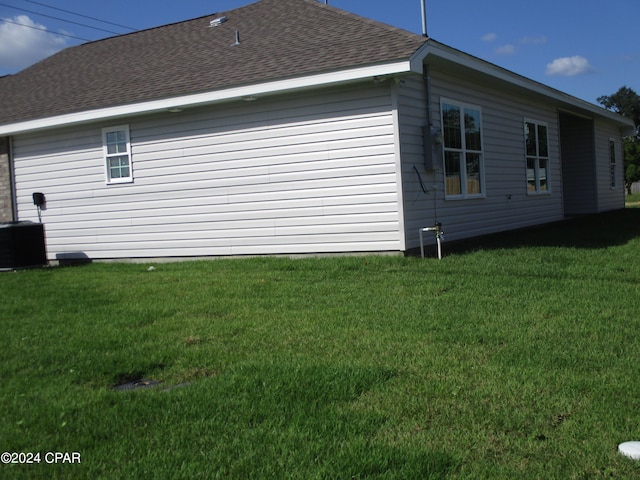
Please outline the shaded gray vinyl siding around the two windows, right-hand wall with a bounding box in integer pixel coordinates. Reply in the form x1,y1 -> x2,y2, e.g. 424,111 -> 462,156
400,69 -> 563,248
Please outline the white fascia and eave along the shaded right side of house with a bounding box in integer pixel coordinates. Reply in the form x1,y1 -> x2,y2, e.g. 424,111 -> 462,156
422,39 -> 633,128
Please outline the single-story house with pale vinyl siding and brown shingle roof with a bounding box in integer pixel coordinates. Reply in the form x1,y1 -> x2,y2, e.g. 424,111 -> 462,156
0,0 -> 633,260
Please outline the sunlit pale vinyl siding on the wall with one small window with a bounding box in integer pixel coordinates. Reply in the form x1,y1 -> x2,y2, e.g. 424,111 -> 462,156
14,84 -> 401,259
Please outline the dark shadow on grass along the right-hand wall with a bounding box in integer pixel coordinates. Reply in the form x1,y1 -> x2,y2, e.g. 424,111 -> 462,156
445,208 -> 640,254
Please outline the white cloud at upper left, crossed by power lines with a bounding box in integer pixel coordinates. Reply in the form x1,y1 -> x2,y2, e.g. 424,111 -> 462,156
0,15 -> 67,72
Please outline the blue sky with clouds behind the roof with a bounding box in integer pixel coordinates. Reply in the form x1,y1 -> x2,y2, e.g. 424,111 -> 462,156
0,0 -> 640,103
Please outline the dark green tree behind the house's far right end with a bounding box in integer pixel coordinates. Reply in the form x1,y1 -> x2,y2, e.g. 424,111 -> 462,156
598,86 -> 640,193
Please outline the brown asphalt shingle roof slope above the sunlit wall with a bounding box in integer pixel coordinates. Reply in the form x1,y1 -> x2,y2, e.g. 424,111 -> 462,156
0,0 -> 426,124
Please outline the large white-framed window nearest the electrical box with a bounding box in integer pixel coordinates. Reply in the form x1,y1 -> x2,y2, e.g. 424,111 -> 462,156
441,100 -> 484,198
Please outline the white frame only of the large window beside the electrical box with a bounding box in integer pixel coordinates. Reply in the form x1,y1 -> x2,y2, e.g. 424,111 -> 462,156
440,98 -> 486,200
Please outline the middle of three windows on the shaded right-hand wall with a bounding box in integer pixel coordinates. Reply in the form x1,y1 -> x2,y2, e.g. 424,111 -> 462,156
524,120 -> 550,194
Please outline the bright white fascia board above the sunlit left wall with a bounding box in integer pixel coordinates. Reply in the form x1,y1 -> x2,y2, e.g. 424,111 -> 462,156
0,60 -> 412,136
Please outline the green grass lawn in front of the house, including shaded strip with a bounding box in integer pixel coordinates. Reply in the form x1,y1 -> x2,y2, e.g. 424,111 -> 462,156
0,208 -> 640,479
